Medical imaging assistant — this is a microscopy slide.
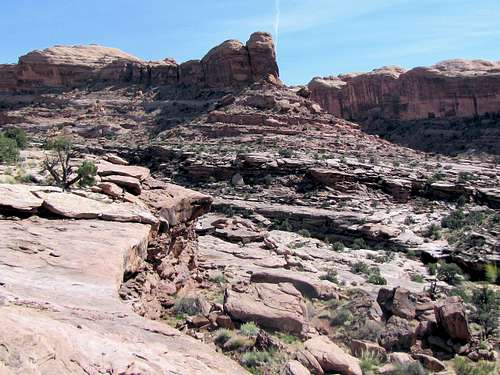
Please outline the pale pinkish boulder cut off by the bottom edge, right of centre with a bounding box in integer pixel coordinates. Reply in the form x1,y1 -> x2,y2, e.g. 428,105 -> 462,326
304,336 -> 362,375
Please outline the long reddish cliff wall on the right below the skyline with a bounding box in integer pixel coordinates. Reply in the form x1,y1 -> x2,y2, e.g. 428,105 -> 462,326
309,60 -> 500,121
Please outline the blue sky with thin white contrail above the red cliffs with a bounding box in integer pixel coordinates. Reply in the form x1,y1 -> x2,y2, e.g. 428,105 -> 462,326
0,0 -> 500,84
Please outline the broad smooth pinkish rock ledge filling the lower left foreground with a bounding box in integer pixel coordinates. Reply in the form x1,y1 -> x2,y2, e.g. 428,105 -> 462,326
0,219 -> 246,375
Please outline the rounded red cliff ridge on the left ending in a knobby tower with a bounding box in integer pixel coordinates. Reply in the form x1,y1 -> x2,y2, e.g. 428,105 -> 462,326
0,32 -> 279,92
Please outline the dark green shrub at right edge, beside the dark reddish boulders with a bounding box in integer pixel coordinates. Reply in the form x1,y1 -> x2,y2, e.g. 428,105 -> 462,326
472,286 -> 500,337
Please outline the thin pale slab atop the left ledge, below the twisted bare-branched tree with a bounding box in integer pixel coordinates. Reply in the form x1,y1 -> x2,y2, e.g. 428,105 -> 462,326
36,192 -> 158,225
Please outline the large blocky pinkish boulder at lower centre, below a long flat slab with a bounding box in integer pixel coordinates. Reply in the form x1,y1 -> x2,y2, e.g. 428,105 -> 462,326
224,283 -> 308,334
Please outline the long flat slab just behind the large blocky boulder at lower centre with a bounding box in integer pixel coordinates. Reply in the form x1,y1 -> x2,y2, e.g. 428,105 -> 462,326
250,269 -> 337,299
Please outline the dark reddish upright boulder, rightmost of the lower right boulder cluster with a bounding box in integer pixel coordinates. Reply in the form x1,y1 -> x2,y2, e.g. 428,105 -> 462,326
434,297 -> 472,342
